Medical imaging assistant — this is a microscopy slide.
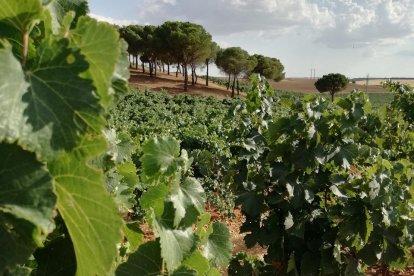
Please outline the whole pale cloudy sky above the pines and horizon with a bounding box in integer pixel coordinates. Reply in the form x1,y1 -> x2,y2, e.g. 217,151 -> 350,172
89,0 -> 414,78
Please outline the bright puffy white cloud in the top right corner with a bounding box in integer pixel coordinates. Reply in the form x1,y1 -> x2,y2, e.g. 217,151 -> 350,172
316,0 -> 414,48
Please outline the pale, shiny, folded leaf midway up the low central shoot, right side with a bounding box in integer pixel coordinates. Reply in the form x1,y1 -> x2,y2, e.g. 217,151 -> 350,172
169,177 -> 206,226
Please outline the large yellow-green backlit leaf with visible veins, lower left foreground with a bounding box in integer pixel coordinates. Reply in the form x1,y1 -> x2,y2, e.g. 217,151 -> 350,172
48,141 -> 122,275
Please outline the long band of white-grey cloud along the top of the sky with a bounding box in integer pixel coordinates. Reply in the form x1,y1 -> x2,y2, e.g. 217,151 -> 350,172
133,0 -> 414,48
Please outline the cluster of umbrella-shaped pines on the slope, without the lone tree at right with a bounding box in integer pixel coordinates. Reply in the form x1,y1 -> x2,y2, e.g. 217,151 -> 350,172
118,21 -> 285,97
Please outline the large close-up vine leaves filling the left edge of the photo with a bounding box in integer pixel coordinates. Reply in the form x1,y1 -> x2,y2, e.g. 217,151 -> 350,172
0,0 -> 131,275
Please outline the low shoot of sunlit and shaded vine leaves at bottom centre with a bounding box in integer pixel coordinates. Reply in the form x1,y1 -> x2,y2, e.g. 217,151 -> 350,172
117,137 -> 231,275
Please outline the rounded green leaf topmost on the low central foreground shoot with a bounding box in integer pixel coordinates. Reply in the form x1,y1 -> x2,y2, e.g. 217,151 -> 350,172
141,137 -> 181,177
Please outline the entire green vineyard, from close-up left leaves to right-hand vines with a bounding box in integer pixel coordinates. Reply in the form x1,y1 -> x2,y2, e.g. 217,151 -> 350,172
0,0 -> 414,276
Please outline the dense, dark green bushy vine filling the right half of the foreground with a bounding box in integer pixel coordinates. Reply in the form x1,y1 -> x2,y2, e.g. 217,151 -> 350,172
231,75 -> 414,275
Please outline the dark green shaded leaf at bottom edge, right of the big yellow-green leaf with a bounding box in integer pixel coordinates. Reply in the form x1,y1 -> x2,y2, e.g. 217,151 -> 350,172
115,240 -> 162,276
